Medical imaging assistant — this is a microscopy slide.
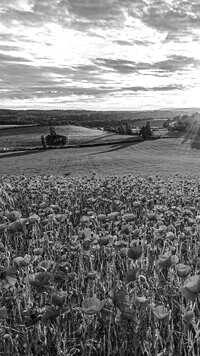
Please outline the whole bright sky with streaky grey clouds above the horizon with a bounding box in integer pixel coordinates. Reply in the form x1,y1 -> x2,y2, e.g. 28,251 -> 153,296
0,0 -> 200,110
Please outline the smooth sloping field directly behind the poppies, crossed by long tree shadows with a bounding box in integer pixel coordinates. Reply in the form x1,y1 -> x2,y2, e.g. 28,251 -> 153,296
0,138 -> 200,178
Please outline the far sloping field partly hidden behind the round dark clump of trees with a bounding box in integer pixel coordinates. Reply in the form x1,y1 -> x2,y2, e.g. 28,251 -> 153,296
0,125 -> 136,150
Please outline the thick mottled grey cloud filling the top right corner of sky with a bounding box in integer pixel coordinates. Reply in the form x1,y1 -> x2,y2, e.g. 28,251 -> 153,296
120,0 -> 200,42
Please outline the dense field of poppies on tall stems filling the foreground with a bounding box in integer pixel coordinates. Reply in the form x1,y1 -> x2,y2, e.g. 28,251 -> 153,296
0,174 -> 200,356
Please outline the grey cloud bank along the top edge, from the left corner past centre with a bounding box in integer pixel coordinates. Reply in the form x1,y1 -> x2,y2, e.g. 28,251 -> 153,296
0,0 -> 125,31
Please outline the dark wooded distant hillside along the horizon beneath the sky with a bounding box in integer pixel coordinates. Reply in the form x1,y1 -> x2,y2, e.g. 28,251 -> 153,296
0,108 -> 200,127
